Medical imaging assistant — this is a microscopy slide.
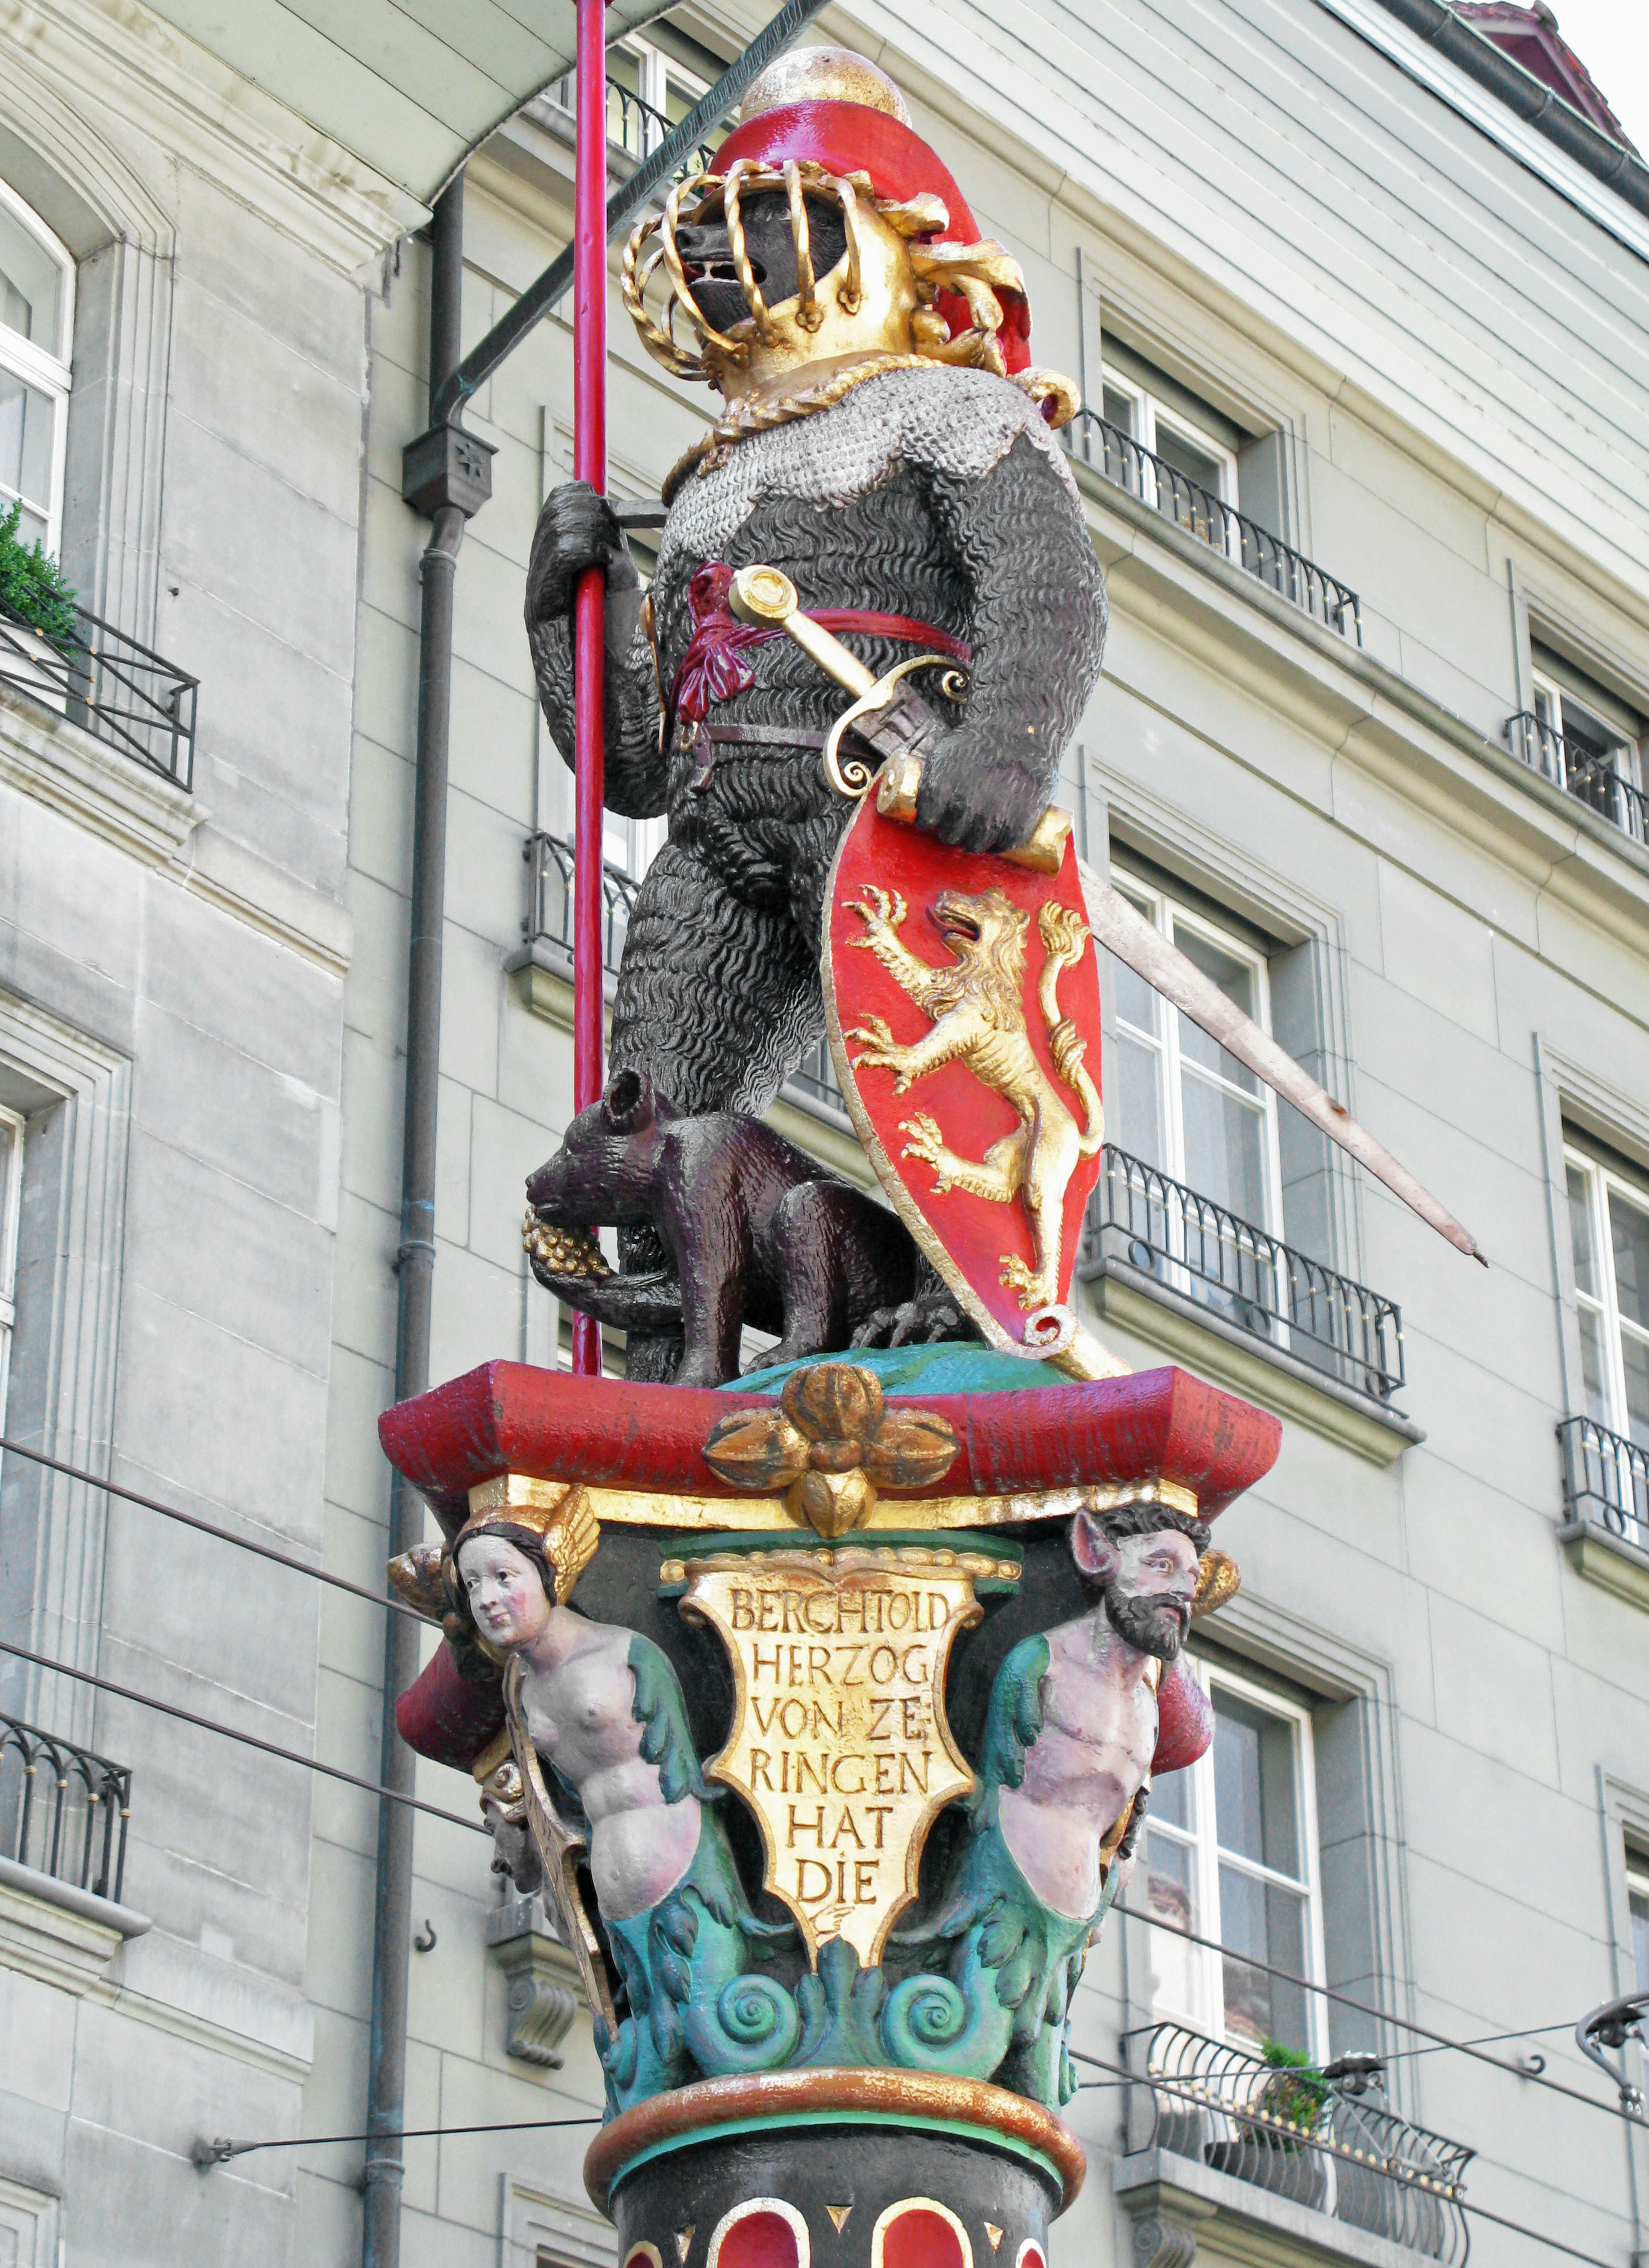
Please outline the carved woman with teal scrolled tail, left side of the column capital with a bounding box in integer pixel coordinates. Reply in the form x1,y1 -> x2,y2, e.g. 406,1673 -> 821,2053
444,1490 -> 798,2109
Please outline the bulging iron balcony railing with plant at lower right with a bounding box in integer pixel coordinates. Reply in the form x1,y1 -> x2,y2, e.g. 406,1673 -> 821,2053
1125,2023 -> 1477,2268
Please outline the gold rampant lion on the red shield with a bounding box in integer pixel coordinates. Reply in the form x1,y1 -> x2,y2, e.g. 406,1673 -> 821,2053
844,882 -> 1104,1311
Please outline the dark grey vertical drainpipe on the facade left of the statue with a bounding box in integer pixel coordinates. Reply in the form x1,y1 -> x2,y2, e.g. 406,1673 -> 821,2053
361,172 -> 490,2268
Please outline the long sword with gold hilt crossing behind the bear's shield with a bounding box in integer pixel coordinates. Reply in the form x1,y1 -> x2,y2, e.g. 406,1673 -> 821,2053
728,567 -> 1488,1268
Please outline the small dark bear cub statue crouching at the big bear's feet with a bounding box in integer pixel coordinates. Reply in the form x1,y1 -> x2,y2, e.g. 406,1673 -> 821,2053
526,1071 -> 966,1386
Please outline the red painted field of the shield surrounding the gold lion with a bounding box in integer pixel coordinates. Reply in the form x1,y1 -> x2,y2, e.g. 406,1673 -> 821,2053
828,796 -> 1100,1340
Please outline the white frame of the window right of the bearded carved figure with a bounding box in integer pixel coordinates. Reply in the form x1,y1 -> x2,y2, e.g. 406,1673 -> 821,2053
1156,1653 -> 1329,2061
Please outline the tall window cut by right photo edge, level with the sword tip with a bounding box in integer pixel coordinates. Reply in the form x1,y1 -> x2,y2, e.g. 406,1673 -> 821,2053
1561,1141 -> 1649,1549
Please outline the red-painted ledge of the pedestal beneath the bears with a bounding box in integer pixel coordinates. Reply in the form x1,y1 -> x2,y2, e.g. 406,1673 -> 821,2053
379,1363 -> 1281,1535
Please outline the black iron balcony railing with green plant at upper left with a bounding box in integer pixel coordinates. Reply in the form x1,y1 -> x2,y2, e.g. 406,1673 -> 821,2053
0,599 -> 200,787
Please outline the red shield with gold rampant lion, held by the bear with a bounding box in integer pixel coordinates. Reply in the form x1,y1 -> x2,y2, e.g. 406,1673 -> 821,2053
823,794 -> 1100,1352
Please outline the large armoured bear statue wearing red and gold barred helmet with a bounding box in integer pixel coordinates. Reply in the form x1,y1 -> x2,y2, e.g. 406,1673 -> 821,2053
526,50 -> 1104,1374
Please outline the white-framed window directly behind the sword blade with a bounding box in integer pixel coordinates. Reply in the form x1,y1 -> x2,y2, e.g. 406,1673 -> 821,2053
1104,873 -> 1281,1232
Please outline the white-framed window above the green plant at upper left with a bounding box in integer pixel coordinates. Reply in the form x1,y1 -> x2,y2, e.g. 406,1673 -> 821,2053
0,181 -> 75,554
